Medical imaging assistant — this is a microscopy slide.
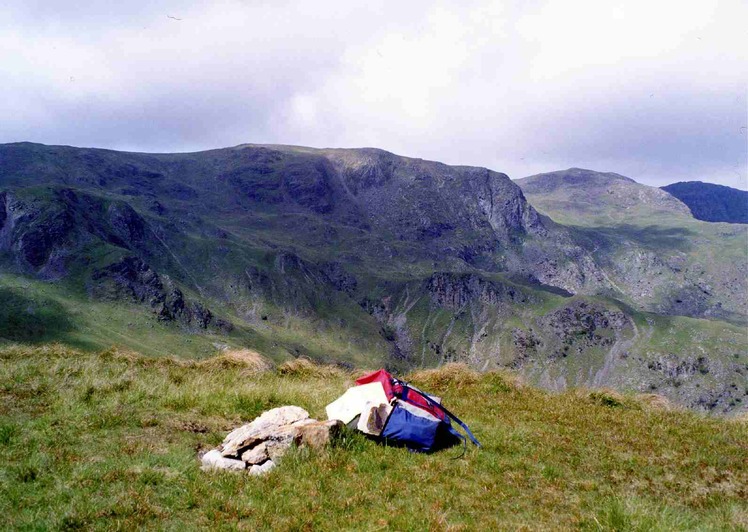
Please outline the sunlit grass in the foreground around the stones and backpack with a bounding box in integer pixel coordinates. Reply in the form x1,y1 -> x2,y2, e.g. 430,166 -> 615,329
0,346 -> 748,530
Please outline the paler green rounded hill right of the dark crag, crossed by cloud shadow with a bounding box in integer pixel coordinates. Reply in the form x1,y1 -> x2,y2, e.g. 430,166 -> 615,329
517,169 -> 748,324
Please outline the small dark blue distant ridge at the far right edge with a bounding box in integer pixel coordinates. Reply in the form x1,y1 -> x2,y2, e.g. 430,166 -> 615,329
662,181 -> 748,224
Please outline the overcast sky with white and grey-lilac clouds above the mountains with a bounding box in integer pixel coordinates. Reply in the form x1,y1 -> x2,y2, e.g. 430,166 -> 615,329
0,0 -> 748,189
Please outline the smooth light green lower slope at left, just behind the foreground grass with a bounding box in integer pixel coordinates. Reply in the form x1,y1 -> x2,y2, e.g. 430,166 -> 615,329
0,274 -> 386,365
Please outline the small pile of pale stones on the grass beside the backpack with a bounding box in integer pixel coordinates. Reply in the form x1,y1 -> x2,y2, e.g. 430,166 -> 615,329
201,406 -> 344,475
